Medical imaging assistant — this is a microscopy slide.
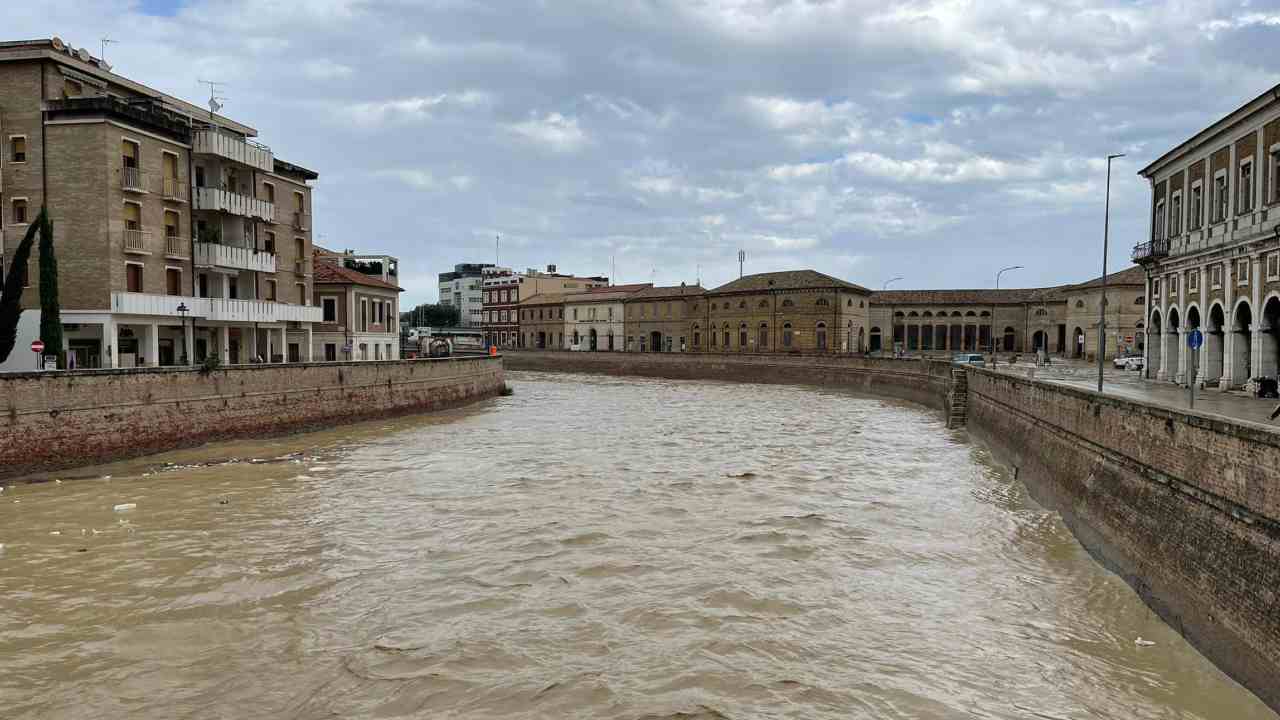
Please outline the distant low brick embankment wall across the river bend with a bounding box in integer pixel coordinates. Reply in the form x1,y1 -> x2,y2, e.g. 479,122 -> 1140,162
504,351 -> 951,410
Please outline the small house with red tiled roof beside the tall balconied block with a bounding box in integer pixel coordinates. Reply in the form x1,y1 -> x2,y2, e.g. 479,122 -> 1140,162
312,249 -> 403,361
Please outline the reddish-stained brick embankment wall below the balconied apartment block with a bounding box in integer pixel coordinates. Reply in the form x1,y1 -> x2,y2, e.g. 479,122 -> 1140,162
0,357 -> 503,477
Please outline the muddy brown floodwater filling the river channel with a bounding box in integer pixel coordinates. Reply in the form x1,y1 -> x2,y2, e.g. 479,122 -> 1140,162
0,373 -> 1276,720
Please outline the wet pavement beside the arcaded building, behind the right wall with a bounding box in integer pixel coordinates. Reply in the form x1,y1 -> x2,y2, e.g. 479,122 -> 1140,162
996,360 -> 1280,430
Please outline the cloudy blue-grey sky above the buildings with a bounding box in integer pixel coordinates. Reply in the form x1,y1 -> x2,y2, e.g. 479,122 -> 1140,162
4,0 -> 1280,302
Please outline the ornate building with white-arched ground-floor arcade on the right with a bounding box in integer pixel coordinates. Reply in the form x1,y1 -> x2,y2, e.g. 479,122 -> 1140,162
1133,86 -> 1280,389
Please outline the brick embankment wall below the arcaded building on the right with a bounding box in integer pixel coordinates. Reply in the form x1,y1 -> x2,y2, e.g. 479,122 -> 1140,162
968,370 -> 1280,708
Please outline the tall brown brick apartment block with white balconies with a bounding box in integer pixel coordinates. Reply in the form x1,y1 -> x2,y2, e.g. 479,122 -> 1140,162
0,38 -> 320,369
